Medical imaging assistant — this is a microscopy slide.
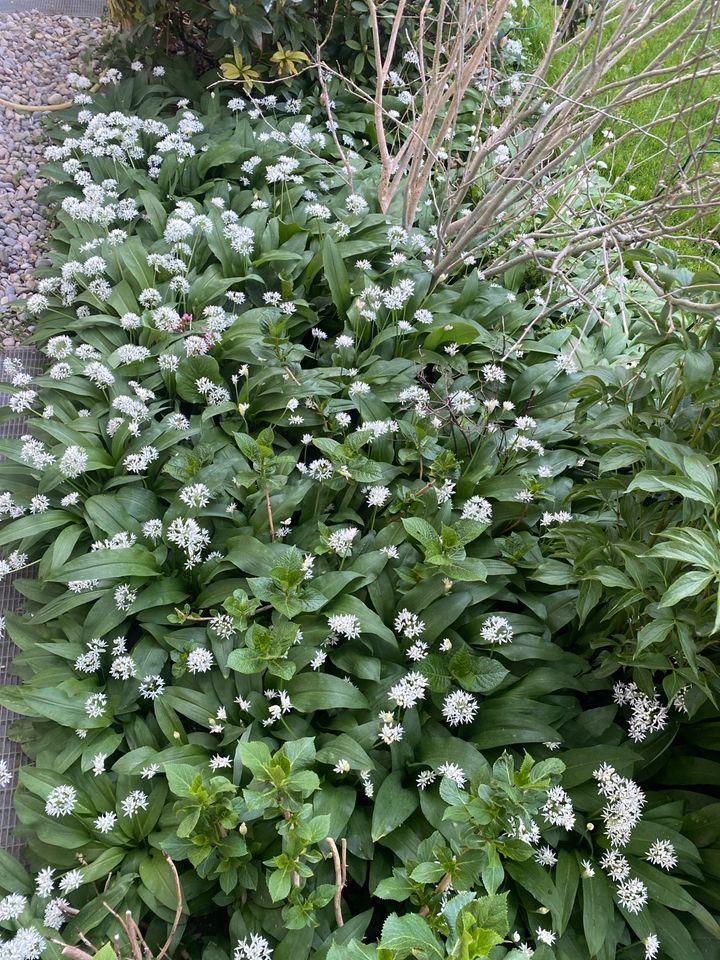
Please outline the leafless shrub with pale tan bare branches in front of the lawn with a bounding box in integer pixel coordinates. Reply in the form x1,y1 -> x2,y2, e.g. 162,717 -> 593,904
319,0 -> 720,282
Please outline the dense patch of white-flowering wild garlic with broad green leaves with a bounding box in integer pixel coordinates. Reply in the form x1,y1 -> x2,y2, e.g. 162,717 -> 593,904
0,69 -> 717,960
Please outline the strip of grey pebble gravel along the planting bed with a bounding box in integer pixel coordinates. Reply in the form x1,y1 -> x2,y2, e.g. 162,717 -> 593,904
0,11 -> 107,349
